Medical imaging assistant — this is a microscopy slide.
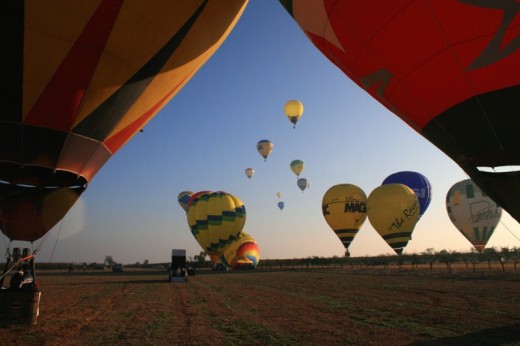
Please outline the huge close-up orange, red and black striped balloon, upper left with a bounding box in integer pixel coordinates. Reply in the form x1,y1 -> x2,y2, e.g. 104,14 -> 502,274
0,0 -> 247,241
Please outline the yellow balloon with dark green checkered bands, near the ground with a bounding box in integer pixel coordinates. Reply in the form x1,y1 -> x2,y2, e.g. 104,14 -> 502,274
188,191 -> 246,257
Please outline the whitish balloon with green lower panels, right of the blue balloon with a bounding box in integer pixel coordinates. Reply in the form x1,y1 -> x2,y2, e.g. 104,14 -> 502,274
446,179 -> 502,252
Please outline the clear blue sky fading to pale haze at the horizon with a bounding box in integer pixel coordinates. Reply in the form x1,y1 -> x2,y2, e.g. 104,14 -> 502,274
4,0 -> 520,264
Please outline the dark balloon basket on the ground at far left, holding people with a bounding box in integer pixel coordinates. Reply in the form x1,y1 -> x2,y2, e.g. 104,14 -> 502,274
0,289 -> 42,327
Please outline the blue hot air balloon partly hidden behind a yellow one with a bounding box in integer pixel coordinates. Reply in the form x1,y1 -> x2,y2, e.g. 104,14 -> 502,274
382,171 -> 432,216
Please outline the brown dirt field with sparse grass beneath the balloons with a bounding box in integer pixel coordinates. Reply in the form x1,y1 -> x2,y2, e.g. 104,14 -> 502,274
0,268 -> 520,345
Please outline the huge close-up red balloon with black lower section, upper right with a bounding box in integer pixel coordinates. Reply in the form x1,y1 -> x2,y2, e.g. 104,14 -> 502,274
280,0 -> 520,222
